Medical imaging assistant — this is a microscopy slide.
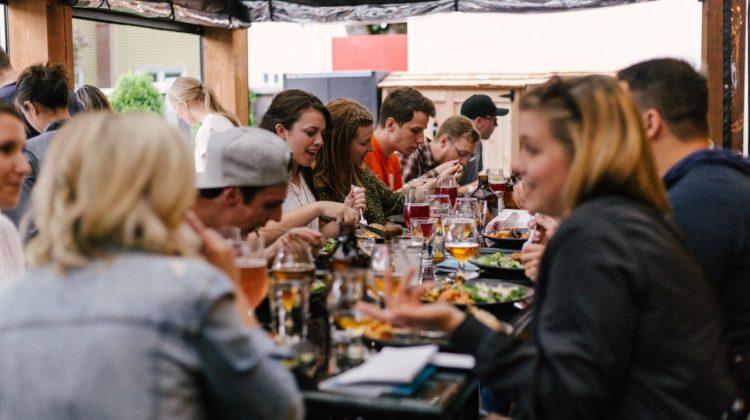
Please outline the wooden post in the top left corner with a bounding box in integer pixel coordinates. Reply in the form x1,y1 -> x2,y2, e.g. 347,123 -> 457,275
8,0 -> 75,83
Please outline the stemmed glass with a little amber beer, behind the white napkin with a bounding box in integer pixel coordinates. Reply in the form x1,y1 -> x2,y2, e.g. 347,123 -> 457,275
327,269 -> 372,368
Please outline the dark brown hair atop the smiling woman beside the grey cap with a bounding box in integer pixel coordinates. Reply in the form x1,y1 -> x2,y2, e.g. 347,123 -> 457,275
260,89 -> 331,134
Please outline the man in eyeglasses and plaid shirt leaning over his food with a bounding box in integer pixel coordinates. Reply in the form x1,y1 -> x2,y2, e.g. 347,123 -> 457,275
399,115 -> 479,182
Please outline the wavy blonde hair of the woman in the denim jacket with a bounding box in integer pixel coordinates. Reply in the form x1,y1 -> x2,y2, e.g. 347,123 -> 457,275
26,113 -> 203,270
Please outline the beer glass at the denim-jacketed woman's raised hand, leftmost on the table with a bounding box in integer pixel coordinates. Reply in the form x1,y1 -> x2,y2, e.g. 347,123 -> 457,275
235,236 -> 268,309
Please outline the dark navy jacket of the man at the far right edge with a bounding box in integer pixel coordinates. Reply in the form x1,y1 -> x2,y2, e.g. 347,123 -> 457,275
664,150 -> 750,360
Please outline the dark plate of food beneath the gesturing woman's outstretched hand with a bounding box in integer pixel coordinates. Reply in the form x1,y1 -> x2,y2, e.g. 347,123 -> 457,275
362,320 -> 449,350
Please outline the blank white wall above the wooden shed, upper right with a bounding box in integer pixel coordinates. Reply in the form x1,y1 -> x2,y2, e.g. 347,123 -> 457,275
408,0 -> 702,73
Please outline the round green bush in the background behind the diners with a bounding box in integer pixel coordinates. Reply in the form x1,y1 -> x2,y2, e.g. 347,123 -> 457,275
112,73 -> 164,115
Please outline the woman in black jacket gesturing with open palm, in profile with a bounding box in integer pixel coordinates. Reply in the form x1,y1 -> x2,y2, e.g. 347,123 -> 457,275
362,76 -> 736,419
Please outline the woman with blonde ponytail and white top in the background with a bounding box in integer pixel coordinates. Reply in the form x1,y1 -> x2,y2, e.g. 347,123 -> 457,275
167,76 -> 240,172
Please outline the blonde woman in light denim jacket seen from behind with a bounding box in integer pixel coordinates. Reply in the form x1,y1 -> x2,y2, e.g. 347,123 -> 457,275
0,113 -> 301,419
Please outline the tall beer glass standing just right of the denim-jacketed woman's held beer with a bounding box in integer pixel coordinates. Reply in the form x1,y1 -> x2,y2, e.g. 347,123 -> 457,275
269,244 -> 315,347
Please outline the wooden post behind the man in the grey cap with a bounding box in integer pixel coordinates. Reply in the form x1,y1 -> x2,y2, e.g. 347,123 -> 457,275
203,28 -> 250,125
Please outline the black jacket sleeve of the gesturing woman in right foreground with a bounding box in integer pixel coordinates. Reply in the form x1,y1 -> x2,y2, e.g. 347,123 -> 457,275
456,221 -> 637,419
